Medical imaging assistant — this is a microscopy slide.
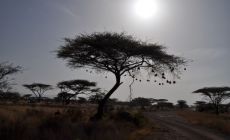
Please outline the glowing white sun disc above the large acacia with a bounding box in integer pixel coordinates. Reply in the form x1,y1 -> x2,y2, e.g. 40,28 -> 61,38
134,0 -> 157,19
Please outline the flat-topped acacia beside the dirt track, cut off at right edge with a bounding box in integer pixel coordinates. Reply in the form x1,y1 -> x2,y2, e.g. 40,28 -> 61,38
193,87 -> 230,115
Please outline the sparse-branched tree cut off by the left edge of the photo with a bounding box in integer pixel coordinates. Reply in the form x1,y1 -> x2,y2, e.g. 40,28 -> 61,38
0,62 -> 22,92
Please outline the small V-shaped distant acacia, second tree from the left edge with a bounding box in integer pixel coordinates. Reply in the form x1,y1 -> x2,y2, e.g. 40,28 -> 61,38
23,83 -> 52,101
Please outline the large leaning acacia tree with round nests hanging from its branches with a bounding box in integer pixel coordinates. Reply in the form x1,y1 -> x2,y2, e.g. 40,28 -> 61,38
57,32 -> 185,119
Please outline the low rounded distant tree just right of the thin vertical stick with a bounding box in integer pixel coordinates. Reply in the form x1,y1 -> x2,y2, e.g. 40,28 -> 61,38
130,97 -> 152,107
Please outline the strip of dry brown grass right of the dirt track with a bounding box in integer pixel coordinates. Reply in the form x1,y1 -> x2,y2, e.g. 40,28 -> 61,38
177,111 -> 230,134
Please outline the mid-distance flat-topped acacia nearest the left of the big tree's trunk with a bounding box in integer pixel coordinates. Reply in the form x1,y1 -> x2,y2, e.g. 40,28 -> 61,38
57,80 -> 96,104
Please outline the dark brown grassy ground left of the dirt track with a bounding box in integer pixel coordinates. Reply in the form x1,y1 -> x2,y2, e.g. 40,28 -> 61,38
0,105 -> 154,140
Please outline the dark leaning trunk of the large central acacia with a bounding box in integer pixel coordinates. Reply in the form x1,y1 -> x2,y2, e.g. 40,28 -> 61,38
91,75 -> 122,120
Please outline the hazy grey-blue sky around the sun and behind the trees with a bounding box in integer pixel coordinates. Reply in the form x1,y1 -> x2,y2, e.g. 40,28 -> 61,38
0,0 -> 230,104
